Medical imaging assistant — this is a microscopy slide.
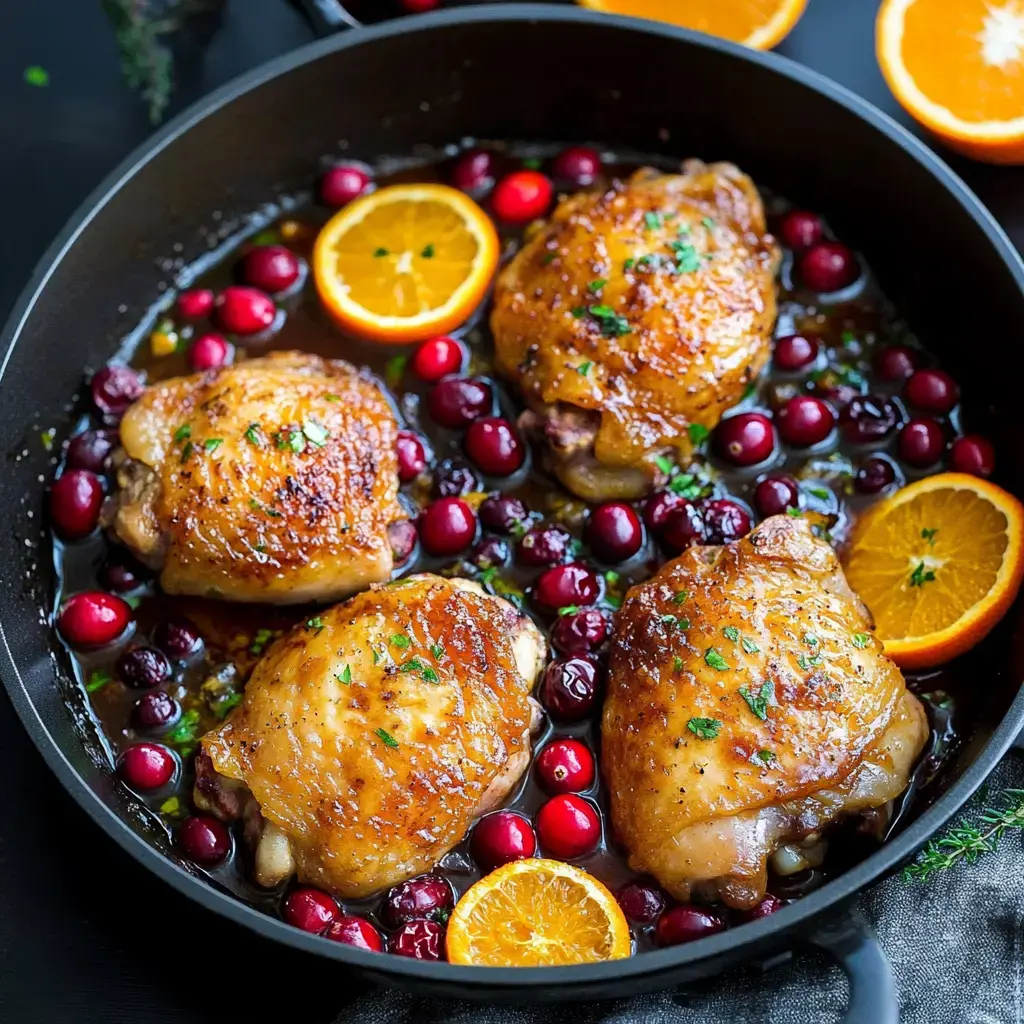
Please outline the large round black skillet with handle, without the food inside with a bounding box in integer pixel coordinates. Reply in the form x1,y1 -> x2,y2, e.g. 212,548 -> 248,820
0,0 -> 1024,1024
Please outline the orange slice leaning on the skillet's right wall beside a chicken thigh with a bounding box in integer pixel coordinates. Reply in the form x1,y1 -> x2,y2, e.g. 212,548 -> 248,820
846,473 -> 1024,669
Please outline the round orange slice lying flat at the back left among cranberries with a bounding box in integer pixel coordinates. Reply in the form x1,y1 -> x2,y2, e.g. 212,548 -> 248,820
312,184 -> 499,344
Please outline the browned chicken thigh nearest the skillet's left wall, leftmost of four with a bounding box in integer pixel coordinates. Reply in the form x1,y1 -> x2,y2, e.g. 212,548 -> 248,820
104,352 -> 406,604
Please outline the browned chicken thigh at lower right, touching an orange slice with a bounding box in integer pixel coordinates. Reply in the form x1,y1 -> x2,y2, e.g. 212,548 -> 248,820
601,516 -> 928,907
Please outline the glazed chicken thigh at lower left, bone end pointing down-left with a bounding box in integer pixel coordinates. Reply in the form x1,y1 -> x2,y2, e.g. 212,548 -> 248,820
196,574 -> 546,898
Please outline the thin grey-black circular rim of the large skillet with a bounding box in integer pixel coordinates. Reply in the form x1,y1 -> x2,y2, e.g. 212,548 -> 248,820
0,3 -> 1024,995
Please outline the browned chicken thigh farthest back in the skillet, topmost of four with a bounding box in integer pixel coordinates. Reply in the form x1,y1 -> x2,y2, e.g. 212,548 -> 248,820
490,160 -> 779,500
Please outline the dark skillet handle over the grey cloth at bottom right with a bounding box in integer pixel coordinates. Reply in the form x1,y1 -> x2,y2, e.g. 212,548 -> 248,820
806,908 -> 899,1024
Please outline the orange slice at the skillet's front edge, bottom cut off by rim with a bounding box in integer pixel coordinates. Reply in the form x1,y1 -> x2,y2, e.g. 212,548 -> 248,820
447,858 -> 633,967
